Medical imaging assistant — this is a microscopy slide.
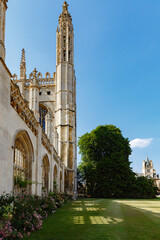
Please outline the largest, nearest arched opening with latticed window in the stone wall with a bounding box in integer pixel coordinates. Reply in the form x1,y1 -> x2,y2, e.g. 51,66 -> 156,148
13,131 -> 34,195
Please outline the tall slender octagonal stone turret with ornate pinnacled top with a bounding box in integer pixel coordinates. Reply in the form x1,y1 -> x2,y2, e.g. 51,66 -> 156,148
55,1 -> 77,191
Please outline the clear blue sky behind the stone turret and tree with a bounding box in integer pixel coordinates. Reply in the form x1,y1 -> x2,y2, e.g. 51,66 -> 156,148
6,0 -> 160,173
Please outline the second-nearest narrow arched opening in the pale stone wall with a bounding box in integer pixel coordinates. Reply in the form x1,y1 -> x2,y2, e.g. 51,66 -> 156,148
42,155 -> 49,193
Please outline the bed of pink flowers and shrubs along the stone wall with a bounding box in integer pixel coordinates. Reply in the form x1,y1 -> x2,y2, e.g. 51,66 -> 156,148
0,193 -> 72,240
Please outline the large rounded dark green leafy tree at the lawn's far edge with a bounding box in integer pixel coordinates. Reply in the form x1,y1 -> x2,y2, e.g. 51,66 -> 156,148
78,125 -> 157,198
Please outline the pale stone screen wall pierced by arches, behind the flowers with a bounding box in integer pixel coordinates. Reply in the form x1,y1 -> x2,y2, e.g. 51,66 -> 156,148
0,61 -> 65,195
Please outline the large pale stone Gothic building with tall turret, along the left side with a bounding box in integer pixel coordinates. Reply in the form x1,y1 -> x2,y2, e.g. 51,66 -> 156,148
0,0 -> 77,195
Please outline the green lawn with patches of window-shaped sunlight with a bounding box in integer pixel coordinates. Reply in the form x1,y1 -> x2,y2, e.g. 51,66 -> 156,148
27,199 -> 160,240
